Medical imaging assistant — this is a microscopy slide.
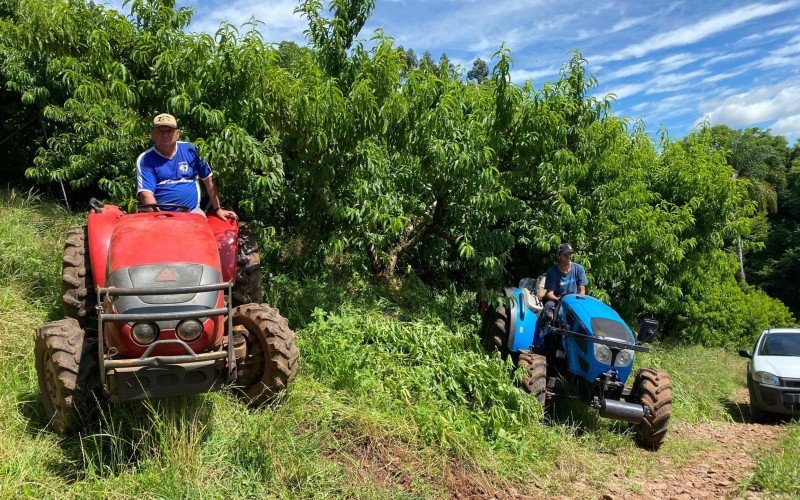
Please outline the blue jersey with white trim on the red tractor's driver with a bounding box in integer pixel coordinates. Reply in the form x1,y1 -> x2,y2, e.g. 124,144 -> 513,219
136,141 -> 211,210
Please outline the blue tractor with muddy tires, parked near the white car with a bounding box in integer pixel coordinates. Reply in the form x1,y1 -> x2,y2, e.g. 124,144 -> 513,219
481,276 -> 672,450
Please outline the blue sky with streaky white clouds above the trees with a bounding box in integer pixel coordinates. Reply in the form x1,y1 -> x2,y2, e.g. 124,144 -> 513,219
133,0 -> 800,144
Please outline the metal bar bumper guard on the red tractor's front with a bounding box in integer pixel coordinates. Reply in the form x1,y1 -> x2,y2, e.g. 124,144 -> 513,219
97,282 -> 237,399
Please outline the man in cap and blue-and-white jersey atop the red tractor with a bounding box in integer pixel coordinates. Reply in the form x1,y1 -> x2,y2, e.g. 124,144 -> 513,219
136,113 -> 238,220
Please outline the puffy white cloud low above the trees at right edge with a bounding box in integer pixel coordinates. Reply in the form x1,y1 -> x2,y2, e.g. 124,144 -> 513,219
698,80 -> 800,126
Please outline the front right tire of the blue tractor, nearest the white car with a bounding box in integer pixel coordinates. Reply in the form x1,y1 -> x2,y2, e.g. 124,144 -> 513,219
628,368 -> 672,450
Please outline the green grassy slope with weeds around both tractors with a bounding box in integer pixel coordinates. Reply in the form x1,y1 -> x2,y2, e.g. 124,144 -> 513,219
0,192 -> 796,498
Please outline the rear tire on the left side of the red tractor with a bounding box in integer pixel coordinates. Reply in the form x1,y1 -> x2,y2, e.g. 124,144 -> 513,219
61,226 -> 97,329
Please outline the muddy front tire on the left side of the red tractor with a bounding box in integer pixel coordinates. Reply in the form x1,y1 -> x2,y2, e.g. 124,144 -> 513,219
34,318 -> 100,434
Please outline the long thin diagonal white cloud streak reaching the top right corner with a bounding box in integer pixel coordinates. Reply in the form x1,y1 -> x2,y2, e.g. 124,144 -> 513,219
598,1 -> 798,61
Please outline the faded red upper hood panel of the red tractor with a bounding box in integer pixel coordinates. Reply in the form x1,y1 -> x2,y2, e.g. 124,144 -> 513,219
106,212 -> 221,275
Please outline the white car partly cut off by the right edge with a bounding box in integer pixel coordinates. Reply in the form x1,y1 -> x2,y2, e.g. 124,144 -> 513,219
739,328 -> 800,420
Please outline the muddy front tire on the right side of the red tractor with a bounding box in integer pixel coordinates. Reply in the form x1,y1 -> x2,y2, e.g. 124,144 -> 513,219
232,304 -> 300,406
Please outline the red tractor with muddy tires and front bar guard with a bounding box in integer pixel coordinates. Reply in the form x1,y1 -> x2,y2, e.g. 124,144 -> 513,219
35,200 -> 299,433
